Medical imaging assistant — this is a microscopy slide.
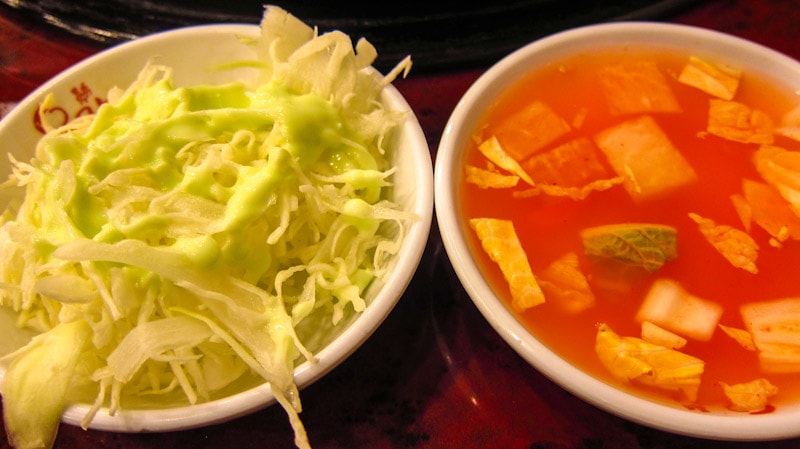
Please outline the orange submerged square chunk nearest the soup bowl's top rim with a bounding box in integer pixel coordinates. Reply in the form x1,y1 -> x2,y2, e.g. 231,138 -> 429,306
599,61 -> 681,115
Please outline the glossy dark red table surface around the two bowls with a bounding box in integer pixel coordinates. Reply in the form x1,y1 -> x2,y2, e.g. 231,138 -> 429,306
0,0 -> 800,449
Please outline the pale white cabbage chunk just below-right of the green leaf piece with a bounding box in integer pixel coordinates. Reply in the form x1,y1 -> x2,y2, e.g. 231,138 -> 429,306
636,279 -> 722,341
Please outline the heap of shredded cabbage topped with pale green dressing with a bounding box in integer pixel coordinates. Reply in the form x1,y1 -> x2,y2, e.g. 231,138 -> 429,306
0,6 -> 416,449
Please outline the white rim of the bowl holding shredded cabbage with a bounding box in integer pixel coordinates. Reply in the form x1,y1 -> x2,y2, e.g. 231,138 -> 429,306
0,23 -> 434,433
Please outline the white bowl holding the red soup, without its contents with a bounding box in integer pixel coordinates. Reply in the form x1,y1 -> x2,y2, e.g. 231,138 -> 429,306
434,22 -> 800,440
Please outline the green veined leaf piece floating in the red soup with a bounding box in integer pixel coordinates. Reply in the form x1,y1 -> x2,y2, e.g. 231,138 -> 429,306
581,223 -> 678,272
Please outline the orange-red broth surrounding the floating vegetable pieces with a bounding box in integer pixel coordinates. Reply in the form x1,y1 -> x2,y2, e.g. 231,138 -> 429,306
462,47 -> 800,412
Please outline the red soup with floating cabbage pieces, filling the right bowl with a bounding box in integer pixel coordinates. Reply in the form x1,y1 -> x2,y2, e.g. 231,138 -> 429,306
462,47 -> 800,413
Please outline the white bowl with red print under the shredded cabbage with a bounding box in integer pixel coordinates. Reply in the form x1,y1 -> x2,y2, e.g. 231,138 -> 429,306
0,25 -> 433,432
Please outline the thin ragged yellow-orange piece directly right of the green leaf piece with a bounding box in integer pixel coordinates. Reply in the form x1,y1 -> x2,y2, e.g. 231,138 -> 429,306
689,212 -> 758,274
